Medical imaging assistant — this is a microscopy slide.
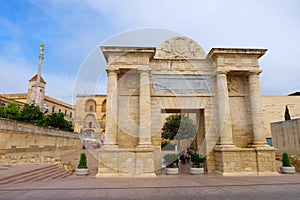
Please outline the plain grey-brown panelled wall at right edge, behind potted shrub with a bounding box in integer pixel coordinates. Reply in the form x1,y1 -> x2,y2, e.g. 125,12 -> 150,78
271,118 -> 300,155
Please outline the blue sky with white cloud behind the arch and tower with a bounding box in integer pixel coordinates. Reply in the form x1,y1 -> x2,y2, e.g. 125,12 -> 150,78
0,0 -> 300,103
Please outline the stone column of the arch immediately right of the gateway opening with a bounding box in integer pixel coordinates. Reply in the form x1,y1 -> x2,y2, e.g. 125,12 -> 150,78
217,71 -> 235,147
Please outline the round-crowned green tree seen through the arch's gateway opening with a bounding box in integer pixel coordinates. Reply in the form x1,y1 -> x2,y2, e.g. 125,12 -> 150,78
161,114 -> 196,150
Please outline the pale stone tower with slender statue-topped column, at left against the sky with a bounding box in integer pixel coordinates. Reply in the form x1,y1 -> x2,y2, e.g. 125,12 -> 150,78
28,44 -> 46,109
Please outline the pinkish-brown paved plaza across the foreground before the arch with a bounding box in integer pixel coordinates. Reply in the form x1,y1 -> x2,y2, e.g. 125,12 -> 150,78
0,162 -> 300,200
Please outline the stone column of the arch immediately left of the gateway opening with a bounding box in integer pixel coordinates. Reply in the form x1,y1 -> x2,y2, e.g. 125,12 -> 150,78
137,67 -> 152,149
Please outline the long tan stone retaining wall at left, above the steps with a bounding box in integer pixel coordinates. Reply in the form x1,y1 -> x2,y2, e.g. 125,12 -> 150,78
0,119 -> 82,164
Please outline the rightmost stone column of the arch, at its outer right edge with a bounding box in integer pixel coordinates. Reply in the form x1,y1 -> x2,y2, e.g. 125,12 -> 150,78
249,71 -> 267,146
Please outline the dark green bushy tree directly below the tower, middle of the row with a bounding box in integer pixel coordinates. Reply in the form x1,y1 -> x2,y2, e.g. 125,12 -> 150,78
20,104 -> 44,124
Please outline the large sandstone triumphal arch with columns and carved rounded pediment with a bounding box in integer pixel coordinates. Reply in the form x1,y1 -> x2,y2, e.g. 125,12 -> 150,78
97,37 -> 277,177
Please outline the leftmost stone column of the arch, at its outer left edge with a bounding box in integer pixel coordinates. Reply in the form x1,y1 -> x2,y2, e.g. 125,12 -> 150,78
103,69 -> 118,148
